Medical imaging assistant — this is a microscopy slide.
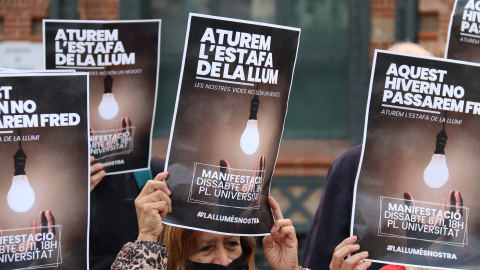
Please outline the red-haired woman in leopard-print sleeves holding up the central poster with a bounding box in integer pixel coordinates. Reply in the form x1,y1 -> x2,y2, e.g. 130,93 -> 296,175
112,172 -> 310,270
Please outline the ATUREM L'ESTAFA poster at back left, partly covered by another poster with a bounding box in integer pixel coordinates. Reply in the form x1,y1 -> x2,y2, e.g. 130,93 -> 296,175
43,20 -> 161,175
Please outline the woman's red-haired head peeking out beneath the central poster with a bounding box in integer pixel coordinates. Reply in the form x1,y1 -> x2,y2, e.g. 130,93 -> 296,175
163,226 -> 255,270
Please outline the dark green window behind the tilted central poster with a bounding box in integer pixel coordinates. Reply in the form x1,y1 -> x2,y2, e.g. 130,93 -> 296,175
129,0 -> 349,139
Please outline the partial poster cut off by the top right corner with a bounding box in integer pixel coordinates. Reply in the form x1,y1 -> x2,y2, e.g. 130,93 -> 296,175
445,0 -> 480,63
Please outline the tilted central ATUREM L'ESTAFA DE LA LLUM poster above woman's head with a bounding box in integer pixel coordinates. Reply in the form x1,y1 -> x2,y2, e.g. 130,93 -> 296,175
163,13 -> 300,235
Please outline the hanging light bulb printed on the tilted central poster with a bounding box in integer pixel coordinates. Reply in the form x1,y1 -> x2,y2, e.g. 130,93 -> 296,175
240,95 -> 260,155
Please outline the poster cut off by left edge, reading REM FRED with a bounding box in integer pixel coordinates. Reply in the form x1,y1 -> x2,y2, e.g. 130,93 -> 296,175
0,71 -> 90,269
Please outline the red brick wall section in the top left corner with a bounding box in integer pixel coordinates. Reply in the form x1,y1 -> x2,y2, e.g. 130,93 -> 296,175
0,0 -> 50,41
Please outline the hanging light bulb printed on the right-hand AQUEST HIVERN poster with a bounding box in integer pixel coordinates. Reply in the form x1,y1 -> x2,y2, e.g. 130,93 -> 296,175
423,112 -> 449,188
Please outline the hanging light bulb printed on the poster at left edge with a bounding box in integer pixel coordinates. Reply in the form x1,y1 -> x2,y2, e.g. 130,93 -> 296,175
7,131 -> 35,213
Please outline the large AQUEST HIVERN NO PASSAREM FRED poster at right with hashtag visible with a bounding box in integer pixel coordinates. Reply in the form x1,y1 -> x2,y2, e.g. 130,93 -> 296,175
351,50 -> 480,269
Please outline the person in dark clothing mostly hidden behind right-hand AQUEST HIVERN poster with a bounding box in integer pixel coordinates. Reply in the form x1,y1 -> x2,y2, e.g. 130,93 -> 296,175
303,42 -> 438,270
